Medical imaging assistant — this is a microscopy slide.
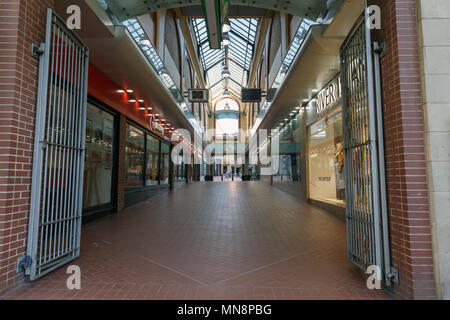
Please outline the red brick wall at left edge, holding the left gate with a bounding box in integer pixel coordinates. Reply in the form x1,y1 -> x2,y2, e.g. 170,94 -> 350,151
0,0 -> 53,292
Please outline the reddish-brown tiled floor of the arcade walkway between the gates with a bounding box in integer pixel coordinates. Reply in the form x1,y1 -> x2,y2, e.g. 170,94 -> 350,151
3,182 -> 389,300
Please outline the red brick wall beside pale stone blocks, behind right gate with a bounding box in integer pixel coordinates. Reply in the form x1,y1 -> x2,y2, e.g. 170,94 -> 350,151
371,0 -> 436,299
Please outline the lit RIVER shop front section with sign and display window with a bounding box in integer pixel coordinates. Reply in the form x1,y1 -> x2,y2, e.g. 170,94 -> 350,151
305,76 -> 345,217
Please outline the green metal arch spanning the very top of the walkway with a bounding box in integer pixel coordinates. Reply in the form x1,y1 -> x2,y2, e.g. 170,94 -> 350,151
100,0 -> 332,21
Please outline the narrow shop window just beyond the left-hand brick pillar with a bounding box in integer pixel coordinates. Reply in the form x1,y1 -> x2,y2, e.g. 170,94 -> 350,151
126,124 -> 145,187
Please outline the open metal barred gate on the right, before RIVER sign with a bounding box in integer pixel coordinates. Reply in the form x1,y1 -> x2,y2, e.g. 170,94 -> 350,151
340,10 -> 394,285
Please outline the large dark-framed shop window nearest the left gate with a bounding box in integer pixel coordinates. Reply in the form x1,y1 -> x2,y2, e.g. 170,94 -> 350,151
83,103 -> 115,208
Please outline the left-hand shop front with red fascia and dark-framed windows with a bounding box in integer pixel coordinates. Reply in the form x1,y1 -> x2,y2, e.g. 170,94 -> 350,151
83,65 -> 178,215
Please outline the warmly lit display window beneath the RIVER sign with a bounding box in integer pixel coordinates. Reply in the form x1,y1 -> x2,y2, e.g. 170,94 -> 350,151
308,108 -> 345,206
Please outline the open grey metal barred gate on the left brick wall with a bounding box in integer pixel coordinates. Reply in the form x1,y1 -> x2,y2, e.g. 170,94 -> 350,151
21,9 -> 89,280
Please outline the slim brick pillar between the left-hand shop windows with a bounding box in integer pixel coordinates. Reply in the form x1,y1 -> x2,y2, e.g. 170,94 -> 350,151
117,114 -> 127,212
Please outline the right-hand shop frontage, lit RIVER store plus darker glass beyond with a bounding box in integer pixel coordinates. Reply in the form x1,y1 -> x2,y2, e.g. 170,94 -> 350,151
271,75 -> 345,218
